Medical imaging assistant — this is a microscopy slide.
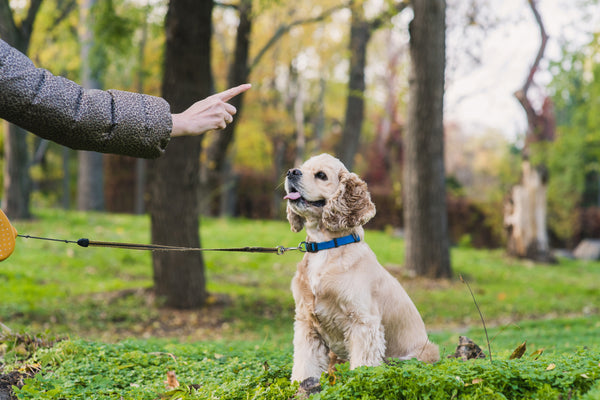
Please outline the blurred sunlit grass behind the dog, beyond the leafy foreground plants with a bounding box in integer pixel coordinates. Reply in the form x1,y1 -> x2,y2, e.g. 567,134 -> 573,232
0,210 -> 600,346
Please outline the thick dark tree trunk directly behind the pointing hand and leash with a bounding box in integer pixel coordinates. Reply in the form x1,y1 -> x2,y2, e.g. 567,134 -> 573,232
148,0 -> 213,309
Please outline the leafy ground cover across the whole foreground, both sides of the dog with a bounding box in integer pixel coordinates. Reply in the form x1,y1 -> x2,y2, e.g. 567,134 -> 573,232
8,340 -> 600,399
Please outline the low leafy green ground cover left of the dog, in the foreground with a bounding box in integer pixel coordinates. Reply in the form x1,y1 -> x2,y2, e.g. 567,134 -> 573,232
12,340 -> 296,399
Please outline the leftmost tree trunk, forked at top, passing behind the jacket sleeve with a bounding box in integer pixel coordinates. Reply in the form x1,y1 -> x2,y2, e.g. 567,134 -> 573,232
0,0 -> 42,219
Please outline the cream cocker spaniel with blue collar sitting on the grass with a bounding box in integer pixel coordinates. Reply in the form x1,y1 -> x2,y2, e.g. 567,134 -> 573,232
284,154 -> 440,383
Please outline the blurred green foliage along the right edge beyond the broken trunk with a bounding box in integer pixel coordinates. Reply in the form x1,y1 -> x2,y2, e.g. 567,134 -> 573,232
548,35 -> 600,238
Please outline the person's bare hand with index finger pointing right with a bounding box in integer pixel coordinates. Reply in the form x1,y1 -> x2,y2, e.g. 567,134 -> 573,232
171,83 -> 252,137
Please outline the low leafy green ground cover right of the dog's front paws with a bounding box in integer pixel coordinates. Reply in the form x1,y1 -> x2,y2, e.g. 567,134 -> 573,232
322,350 -> 600,399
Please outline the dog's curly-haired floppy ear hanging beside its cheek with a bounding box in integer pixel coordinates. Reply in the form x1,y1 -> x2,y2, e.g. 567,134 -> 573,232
323,171 -> 375,231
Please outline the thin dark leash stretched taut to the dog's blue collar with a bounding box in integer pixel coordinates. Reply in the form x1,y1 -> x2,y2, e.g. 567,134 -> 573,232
17,235 -> 306,255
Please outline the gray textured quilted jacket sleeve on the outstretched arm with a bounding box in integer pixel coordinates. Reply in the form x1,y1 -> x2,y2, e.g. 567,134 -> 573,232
0,39 -> 172,158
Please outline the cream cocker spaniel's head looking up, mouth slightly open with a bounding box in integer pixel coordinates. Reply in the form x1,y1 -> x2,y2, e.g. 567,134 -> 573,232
284,154 -> 375,232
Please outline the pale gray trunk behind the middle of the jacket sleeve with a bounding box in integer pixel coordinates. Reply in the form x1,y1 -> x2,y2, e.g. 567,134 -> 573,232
77,0 -> 104,211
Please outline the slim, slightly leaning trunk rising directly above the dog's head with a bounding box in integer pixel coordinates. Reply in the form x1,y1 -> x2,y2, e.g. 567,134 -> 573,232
336,2 -> 372,170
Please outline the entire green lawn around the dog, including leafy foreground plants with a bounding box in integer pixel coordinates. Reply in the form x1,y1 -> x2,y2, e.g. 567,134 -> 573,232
0,210 -> 600,399
